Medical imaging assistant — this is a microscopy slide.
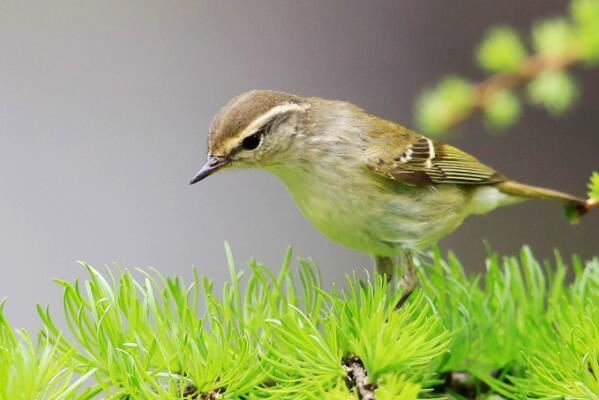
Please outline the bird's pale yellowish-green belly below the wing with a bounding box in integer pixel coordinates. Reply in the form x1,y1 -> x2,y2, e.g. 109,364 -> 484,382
276,169 -> 464,256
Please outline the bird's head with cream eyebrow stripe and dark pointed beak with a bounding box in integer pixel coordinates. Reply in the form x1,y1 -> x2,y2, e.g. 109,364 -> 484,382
191,90 -> 310,184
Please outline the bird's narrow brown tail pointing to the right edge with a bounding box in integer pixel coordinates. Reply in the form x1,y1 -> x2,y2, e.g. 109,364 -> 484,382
497,181 -> 591,224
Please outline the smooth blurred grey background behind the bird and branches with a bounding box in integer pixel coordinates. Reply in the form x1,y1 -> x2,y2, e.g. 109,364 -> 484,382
0,0 -> 599,328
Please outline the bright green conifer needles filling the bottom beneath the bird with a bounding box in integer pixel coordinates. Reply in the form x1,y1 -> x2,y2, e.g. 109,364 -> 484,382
0,245 -> 599,400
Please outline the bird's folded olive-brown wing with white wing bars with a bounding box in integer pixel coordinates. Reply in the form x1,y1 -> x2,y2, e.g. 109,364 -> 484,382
365,127 -> 506,186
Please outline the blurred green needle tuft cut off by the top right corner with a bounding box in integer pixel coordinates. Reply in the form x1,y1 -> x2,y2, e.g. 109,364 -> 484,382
570,0 -> 599,62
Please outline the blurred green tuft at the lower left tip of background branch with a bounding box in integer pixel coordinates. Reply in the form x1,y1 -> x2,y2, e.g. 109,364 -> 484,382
416,76 -> 474,136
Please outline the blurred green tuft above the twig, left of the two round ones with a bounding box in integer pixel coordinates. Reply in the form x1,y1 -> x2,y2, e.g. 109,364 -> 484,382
476,27 -> 527,72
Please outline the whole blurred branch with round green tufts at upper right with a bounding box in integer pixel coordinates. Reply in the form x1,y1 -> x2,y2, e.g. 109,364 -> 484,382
416,0 -> 599,208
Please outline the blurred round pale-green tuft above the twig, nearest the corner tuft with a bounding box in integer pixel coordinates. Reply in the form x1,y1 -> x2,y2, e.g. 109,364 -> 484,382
532,18 -> 576,56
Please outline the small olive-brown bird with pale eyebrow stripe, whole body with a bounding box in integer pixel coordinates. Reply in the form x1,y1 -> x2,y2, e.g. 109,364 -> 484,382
191,90 -> 590,294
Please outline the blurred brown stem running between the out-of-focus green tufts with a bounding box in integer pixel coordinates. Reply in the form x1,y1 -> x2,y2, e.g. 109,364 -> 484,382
446,52 -> 580,130
